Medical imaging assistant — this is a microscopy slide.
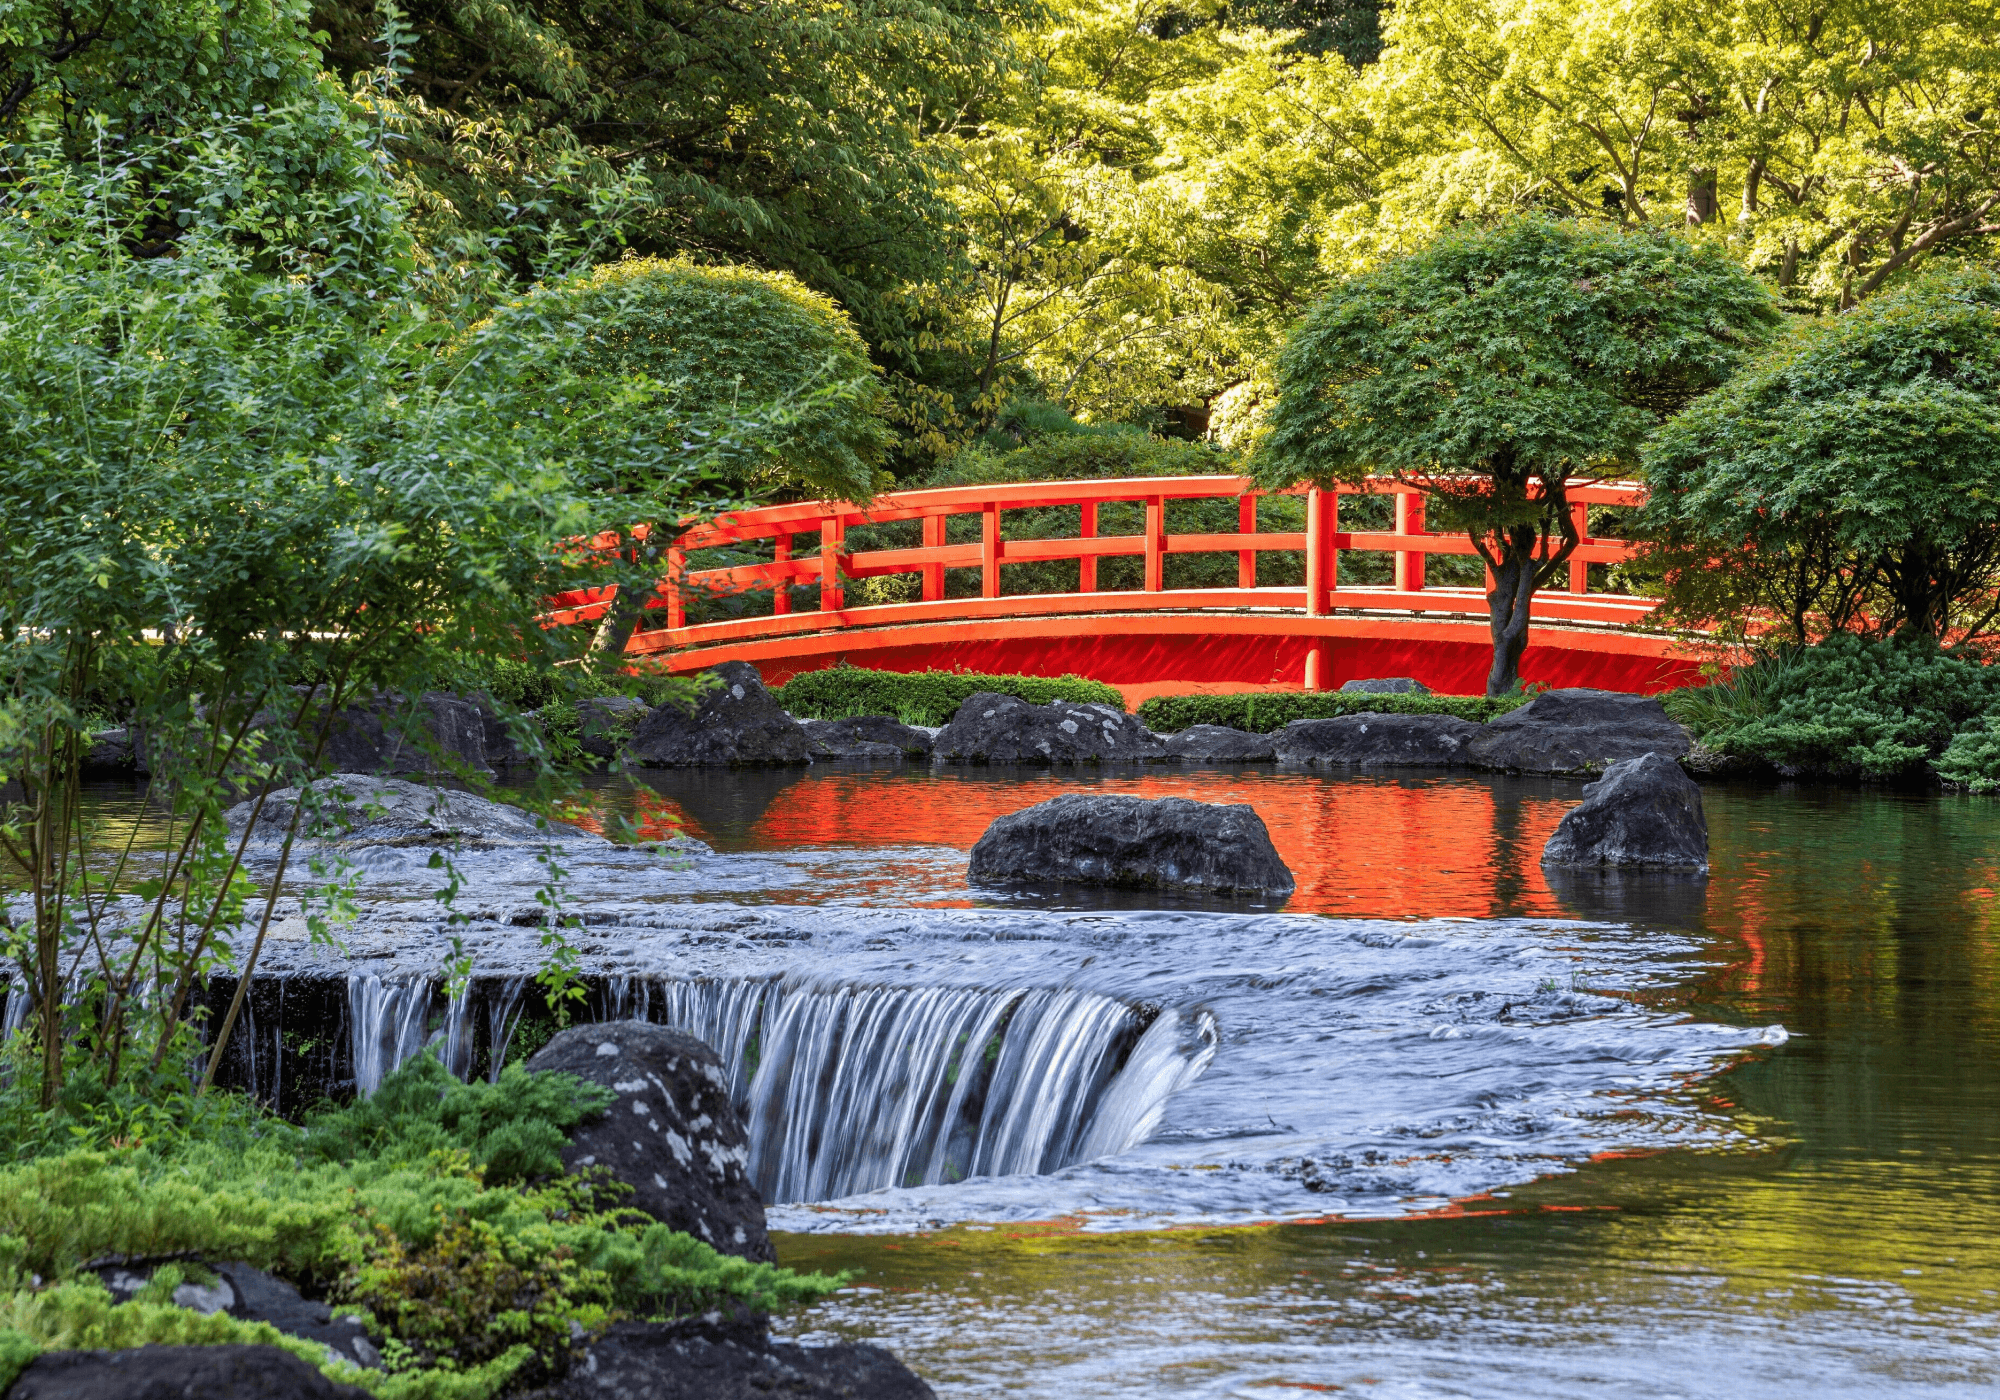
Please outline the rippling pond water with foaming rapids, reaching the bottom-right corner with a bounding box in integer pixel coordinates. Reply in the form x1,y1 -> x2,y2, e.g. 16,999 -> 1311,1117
70,766 -> 2000,1400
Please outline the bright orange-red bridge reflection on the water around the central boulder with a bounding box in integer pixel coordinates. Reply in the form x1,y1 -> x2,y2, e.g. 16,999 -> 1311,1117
694,772 -> 1572,918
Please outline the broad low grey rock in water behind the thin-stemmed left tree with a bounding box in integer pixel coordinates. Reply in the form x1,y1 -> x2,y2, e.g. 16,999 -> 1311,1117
224,772 -> 604,850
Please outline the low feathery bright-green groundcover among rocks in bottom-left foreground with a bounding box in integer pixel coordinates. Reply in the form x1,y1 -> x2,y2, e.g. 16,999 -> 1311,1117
0,1046 -> 842,1400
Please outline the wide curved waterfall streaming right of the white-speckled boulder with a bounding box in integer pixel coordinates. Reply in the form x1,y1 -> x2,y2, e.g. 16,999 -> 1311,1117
658,982 -> 1214,1202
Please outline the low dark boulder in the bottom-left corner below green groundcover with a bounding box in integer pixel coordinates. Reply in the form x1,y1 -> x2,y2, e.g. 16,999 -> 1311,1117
6,1346 -> 368,1400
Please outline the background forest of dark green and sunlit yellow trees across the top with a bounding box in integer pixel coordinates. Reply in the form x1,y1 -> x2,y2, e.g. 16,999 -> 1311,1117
0,0 -> 2000,470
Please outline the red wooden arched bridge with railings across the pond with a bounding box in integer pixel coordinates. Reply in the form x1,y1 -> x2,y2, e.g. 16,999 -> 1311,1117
552,476 -> 1698,704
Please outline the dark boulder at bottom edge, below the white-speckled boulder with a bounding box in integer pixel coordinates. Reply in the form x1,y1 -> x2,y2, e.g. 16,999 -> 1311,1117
548,1318 -> 934,1400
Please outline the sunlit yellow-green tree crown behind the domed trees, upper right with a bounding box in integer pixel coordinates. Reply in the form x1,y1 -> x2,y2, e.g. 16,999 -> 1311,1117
1364,0 -> 2000,306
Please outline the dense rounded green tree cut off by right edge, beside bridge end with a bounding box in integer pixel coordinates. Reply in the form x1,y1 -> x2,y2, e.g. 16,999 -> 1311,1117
1644,270 -> 2000,642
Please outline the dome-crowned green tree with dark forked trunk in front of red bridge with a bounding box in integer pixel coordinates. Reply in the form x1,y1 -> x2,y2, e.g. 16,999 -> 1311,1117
1258,218 -> 1778,696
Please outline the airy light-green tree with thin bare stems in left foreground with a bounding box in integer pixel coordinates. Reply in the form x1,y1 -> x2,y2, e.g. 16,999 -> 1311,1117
0,161 -> 756,1104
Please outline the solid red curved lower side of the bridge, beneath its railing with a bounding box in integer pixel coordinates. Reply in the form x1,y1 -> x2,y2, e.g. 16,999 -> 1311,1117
632,612 -> 1700,706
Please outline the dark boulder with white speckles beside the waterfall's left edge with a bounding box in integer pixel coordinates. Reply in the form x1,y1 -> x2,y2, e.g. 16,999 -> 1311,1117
528,1020 -> 778,1262
